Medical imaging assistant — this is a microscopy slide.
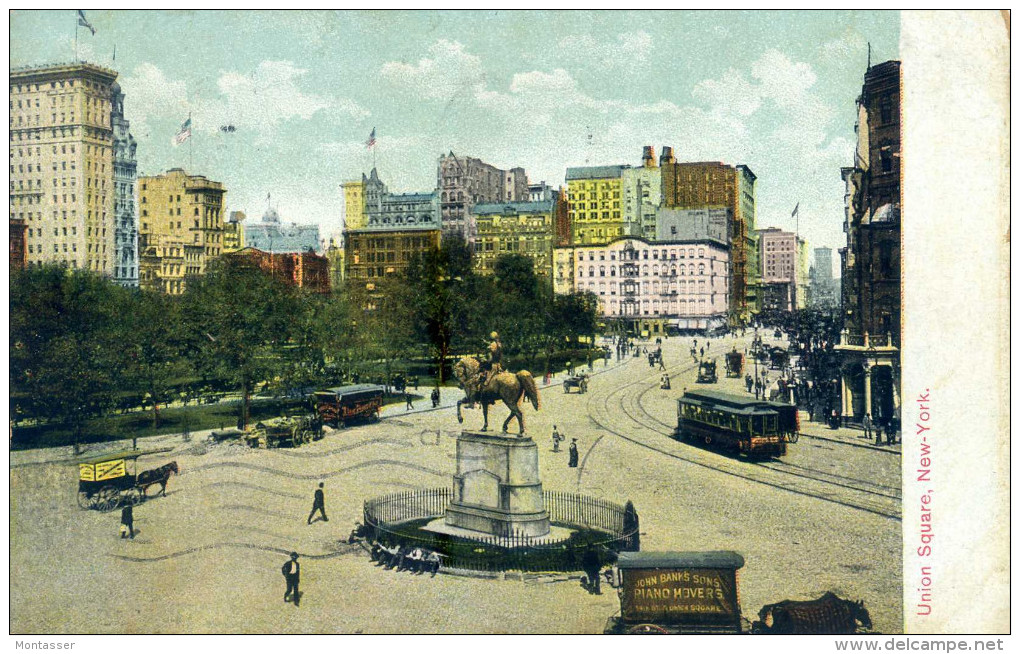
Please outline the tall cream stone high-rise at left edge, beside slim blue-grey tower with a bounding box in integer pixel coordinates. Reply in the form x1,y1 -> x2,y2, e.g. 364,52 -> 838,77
9,63 -> 117,276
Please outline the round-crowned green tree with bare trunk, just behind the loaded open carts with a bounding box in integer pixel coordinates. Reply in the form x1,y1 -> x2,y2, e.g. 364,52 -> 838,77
183,256 -> 300,429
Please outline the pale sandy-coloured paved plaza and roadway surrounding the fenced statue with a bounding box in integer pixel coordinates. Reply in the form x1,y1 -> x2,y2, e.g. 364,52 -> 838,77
10,330 -> 902,634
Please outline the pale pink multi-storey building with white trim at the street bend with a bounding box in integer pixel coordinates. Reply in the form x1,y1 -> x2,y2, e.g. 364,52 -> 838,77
557,237 -> 729,334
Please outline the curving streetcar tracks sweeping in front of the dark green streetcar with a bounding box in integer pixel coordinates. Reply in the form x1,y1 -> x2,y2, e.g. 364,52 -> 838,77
589,348 -> 901,520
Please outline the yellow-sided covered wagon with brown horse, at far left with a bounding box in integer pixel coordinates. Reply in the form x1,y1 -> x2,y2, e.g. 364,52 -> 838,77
78,450 -> 179,511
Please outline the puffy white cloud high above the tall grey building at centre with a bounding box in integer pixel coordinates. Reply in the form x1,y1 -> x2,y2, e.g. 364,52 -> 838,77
379,39 -> 486,100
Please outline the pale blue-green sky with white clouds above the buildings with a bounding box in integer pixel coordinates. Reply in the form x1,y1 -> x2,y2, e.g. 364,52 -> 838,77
10,10 -> 900,269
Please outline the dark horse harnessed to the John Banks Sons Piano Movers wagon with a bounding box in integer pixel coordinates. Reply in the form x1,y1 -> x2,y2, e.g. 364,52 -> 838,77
752,593 -> 872,635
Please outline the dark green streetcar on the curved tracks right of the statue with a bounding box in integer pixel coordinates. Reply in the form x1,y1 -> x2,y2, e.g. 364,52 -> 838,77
674,391 -> 800,457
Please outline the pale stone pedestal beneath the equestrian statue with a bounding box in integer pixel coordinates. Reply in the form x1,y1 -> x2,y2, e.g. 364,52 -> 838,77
446,432 -> 549,537
